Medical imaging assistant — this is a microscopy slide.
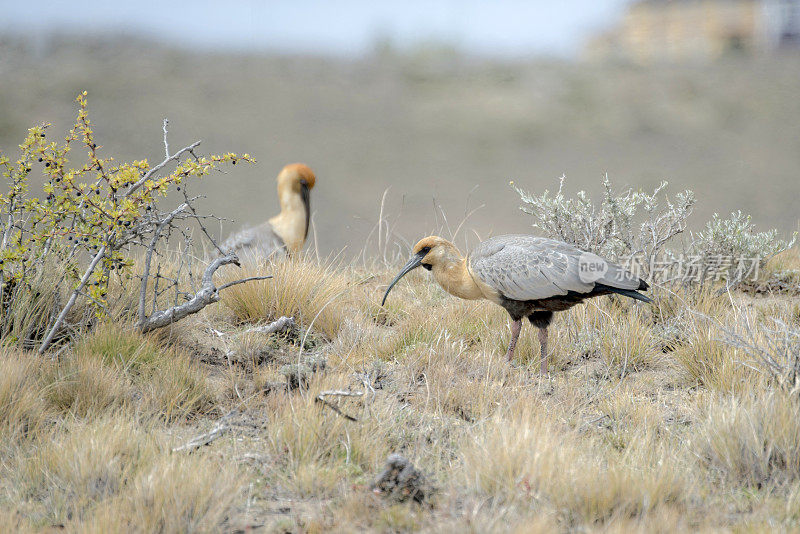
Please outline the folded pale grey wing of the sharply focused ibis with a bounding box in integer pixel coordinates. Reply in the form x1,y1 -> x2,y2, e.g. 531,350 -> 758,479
470,235 -> 639,300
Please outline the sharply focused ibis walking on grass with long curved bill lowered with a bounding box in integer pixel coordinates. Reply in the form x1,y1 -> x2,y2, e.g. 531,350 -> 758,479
381,235 -> 652,374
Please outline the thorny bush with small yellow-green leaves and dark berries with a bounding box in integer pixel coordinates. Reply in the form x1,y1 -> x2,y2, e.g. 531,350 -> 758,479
0,91 -> 253,352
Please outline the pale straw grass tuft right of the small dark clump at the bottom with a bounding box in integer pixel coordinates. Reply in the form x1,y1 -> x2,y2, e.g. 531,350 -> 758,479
464,410 -> 688,524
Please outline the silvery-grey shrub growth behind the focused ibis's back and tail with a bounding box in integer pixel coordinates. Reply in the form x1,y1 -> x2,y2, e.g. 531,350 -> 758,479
511,176 -> 796,288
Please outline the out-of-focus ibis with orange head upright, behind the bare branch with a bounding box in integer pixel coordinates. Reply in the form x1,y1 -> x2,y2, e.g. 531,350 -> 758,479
222,163 -> 316,259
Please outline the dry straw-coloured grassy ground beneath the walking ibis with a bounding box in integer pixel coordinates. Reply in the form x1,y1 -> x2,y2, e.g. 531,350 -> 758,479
0,246 -> 800,532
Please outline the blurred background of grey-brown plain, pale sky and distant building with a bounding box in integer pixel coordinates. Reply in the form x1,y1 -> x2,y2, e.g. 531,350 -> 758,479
0,0 -> 800,256
